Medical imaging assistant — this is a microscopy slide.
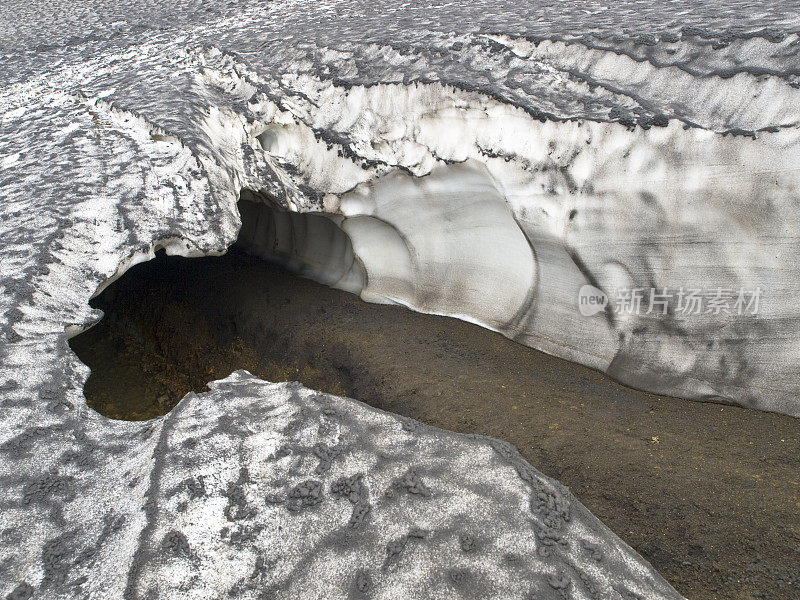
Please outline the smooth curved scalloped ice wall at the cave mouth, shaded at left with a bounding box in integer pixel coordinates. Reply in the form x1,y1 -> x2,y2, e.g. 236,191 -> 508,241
239,164 -> 536,332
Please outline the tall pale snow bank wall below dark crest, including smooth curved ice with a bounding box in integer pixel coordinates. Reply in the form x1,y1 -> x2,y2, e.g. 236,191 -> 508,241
223,69 -> 800,414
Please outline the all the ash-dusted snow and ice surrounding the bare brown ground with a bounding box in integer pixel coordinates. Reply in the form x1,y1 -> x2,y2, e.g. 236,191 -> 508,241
0,0 -> 800,600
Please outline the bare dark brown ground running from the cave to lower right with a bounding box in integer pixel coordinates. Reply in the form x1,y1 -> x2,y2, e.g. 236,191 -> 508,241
71,250 -> 800,600
